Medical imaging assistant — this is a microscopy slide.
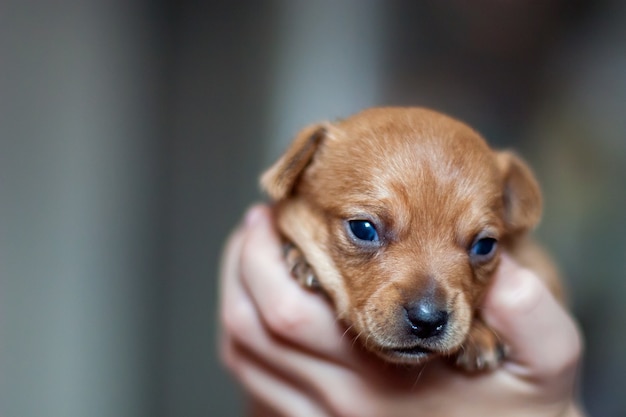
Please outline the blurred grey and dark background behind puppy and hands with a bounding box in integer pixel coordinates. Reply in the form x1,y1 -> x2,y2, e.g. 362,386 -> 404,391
0,0 -> 626,417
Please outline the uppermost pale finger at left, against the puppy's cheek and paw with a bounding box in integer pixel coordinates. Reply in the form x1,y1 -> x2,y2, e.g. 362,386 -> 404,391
241,208 -> 352,362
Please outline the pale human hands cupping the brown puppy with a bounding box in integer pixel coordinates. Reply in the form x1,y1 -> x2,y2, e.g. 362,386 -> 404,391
220,206 -> 584,417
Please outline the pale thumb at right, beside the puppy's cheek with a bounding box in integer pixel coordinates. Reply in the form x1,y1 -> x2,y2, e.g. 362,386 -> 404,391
485,257 -> 582,380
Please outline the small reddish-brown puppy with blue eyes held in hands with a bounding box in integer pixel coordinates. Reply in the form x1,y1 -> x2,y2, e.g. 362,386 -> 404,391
261,108 -> 561,371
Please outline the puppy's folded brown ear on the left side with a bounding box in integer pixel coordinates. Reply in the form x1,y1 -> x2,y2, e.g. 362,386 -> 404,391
261,124 -> 327,200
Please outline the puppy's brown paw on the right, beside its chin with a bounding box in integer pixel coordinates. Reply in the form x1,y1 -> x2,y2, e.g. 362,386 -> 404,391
455,321 -> 507,372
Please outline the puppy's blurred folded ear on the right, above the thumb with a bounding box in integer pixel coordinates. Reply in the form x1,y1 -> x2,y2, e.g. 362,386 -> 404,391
497,152 -> 542,233
